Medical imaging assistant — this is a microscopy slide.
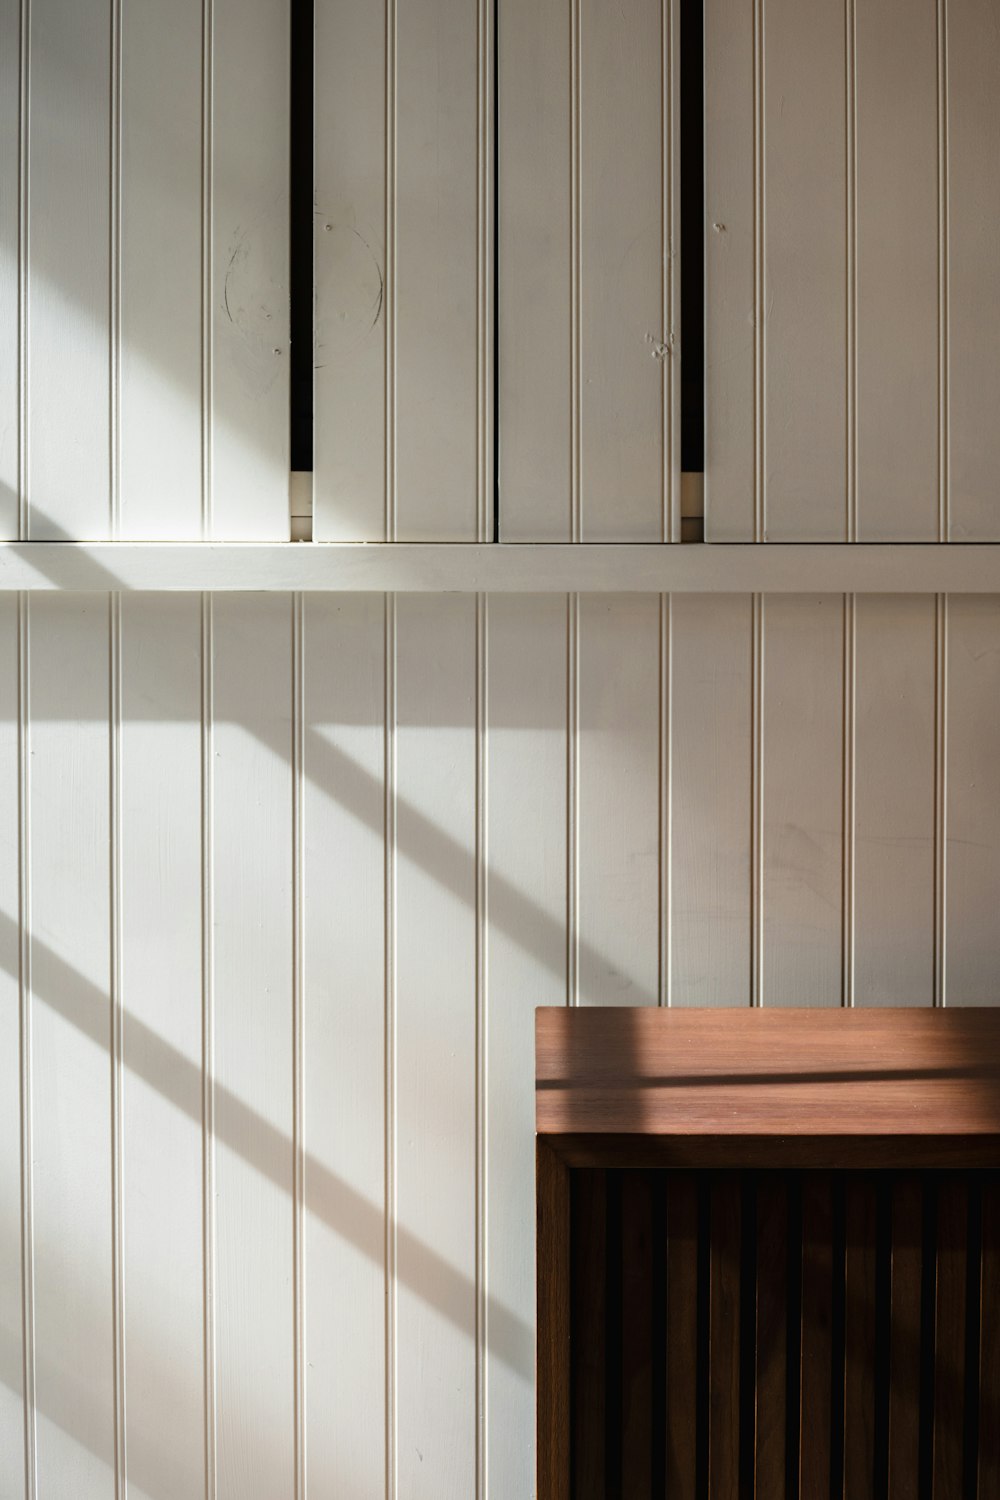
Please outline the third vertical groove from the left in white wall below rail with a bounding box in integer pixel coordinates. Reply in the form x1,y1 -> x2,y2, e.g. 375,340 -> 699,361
201,594 -> 219,1500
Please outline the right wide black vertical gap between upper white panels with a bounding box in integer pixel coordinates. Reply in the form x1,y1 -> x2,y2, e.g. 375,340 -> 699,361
679,0 -> 705,471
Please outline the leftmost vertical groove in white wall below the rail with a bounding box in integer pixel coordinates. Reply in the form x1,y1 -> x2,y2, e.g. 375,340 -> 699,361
16,594 -> 37,1500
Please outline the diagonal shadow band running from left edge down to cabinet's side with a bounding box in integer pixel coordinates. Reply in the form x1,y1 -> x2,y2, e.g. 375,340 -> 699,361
0,912 -> 535,1380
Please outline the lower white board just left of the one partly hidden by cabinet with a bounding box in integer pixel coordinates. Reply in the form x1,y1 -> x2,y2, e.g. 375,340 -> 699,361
396,596 -> 477,1500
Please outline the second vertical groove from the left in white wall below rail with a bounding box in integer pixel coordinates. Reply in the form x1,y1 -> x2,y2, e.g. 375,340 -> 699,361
108,591 -> 127,1500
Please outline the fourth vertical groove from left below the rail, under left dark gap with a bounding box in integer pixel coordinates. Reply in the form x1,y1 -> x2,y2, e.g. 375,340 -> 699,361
291,594 -> 307,1500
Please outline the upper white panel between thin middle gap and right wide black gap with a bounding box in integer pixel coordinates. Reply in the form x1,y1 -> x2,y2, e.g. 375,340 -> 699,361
499,0 -> 679,542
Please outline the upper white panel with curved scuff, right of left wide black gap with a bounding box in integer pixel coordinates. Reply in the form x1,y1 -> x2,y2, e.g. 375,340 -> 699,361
315,0 -> 493,542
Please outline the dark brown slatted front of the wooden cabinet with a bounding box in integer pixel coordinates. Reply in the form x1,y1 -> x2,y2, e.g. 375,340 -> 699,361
563,1169 -> 1000,1500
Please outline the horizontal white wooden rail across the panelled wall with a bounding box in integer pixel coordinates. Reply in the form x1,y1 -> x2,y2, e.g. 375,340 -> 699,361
0,542 -> 1000,594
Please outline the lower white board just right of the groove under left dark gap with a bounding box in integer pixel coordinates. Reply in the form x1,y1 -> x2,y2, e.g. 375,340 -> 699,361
303,594 -> 387,1494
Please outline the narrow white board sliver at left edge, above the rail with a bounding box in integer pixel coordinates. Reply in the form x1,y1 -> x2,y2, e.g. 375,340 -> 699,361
0,0 -> 22,537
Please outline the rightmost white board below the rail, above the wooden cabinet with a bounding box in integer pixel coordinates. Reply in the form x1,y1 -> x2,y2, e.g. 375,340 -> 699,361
946,594 -> 1000,1005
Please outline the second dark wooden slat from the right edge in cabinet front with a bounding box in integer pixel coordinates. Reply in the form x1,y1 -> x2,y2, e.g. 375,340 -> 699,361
934,1173 -> 971,1500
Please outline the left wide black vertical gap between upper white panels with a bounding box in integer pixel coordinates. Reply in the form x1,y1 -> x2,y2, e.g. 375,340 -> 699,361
288,0 -> 315,470
